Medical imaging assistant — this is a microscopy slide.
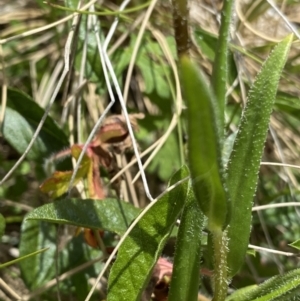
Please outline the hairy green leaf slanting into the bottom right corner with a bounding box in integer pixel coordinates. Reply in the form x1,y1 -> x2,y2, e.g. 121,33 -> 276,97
226,269 -> 300,301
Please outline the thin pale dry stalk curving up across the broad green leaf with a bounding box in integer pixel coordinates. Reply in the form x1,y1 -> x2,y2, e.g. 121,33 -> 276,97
85,177 -> 189,301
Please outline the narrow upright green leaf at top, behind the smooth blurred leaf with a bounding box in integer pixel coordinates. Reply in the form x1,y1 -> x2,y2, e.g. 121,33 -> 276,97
212,0 -> 233,129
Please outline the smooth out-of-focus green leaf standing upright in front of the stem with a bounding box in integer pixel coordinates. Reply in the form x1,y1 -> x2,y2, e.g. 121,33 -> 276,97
180,57 -> 230,230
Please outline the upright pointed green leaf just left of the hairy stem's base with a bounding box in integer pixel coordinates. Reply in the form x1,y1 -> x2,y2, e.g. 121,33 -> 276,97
168,187 -> 204,301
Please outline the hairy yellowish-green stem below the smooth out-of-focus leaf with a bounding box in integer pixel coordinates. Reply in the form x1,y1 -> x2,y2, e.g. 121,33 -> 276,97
212,230 -> 228,301
